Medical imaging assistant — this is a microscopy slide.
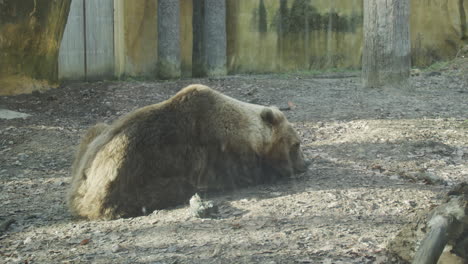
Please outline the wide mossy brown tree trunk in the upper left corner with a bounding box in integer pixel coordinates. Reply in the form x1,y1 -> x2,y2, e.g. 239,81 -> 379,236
0,0 -> 71,94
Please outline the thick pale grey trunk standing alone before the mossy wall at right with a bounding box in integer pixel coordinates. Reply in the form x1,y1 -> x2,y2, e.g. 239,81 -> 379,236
362,0 -> 411,88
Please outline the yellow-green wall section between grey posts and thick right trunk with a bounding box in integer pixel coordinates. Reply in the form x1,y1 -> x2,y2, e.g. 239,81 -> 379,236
228,0 -> 362,73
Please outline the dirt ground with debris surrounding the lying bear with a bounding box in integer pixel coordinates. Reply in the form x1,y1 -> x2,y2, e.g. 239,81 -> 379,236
0,60 -> 468,264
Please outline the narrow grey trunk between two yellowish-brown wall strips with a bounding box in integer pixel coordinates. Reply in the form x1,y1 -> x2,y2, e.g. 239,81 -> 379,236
157,0 -> 181,79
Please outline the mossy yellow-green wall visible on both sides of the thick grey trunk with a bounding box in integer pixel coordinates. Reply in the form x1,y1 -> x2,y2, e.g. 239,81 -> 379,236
227,0 -> 468,73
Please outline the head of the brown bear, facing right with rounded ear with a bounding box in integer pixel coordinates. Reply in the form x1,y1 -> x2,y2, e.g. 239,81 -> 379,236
261,107 -> 308,176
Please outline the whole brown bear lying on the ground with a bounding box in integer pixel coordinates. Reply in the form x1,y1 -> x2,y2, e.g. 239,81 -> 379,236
68,85 -> 307,219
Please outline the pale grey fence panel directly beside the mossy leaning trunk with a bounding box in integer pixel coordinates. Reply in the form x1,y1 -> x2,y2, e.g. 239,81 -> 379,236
58,0 -> 86,80
